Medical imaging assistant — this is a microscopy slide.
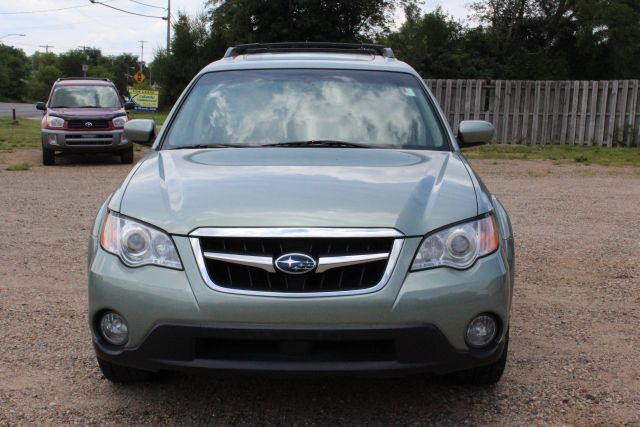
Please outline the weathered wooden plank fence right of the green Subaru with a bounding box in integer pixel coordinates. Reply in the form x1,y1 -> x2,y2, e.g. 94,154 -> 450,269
425,80 -> 640,147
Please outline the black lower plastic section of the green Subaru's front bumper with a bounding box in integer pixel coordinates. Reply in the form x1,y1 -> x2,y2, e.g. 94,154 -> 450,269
93,324 -> 505,375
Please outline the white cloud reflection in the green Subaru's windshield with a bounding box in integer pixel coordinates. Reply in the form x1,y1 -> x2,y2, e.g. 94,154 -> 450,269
202,80 -> 426,145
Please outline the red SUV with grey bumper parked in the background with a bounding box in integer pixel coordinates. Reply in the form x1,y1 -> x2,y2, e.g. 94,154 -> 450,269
36,77 -> 133,165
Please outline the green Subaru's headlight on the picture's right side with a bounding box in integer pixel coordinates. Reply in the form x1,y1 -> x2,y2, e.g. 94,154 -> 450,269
411,215 -> 499,271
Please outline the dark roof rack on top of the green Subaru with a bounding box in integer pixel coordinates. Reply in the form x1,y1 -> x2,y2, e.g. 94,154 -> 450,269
224,42 -> 395,58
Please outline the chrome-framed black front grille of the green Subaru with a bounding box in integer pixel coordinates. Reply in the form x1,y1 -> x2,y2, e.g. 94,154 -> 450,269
191,228 -> 403,297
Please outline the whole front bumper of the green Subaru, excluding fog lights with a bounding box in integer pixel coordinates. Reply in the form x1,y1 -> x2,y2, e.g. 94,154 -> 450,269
89,236 -> 512,373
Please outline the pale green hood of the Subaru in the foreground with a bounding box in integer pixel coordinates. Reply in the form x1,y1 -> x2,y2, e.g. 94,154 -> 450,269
117,148 -> 478,236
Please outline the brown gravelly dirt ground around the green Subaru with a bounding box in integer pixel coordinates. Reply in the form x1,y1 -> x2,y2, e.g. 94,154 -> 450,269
0,150 -> 640,425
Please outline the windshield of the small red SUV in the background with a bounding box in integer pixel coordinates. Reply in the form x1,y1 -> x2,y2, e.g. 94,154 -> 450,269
49,86 -> 121,108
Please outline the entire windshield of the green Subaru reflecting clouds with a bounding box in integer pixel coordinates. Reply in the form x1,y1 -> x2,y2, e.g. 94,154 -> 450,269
163,69 -> 449,150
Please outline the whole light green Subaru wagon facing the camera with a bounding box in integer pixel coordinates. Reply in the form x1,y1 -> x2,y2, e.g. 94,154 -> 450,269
89,43 -> 514,384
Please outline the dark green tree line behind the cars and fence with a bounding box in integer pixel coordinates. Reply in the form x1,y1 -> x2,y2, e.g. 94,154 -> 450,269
0,0 -> 640,105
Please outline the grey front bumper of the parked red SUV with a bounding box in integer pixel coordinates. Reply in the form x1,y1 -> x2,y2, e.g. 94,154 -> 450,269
42,129 -> 132,152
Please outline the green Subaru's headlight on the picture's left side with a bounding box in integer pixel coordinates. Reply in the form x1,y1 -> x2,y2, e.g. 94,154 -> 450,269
100,212 -> 182,270
